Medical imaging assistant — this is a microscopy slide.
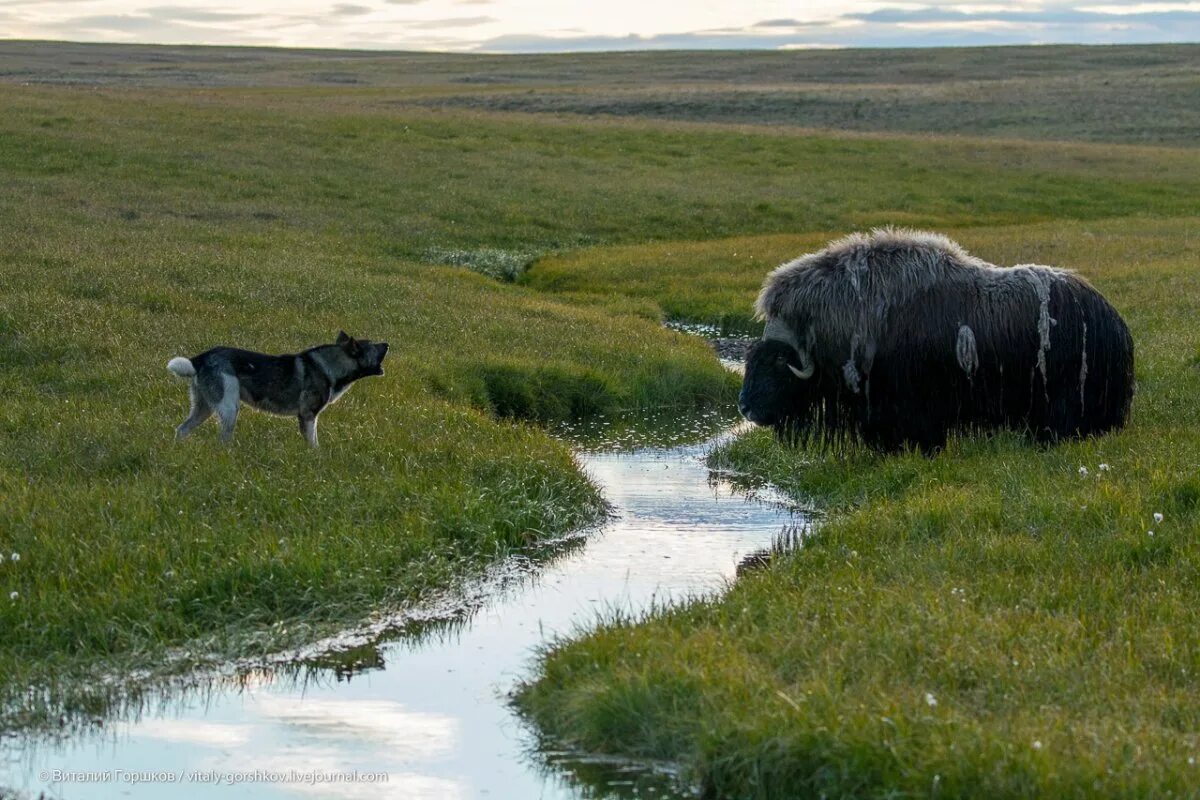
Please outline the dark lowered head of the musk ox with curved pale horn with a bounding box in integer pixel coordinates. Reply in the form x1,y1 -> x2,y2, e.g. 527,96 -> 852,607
738,319 -> 817,429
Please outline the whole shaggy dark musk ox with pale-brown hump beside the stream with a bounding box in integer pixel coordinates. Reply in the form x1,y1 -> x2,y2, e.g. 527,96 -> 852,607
739,229 -> 1134,452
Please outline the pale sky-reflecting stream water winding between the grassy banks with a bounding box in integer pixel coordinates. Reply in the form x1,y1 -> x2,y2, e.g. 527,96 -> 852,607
0,412 -> 803,800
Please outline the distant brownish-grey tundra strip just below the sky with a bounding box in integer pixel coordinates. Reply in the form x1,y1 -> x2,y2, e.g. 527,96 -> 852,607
9,42 -> 1200,146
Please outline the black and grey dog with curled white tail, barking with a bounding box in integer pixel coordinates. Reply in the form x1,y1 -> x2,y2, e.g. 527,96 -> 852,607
167,331 -> 388,447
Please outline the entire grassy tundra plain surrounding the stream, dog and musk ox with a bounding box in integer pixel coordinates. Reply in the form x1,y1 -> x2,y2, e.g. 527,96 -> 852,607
0,42 -> 1200,798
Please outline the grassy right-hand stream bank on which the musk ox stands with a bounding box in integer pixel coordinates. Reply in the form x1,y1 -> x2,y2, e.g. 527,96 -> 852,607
520,218 -> 1200,798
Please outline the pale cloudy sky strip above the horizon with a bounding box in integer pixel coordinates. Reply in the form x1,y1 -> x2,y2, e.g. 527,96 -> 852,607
0,0 -> 1200,52
